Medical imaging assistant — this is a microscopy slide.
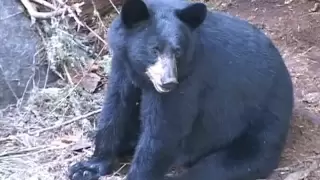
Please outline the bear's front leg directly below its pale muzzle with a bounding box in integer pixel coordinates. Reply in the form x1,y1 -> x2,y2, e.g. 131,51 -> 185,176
127,92 -> 193,180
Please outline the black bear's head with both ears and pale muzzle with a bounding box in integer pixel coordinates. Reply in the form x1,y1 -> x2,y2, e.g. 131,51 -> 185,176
108,0 -> 207,93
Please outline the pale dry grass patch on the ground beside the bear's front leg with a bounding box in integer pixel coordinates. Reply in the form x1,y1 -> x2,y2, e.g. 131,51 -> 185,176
0,85 -> 103,180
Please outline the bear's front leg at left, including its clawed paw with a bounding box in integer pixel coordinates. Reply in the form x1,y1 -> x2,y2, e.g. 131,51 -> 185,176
69,59 -> 141,180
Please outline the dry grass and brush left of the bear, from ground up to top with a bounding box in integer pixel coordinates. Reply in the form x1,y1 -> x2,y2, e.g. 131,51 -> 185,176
0,1 -> 119,180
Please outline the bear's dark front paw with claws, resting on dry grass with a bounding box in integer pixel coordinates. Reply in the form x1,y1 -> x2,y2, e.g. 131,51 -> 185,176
69,159 -> 113,180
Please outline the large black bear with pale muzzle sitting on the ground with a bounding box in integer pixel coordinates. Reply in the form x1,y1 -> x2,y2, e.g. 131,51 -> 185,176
69,0 -> 294,180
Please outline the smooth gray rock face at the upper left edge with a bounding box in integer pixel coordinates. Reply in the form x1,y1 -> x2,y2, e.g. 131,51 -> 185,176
0,0 -> 57,108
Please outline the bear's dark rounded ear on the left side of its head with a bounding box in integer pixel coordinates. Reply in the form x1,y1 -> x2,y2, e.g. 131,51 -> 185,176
120,0 -> 150,28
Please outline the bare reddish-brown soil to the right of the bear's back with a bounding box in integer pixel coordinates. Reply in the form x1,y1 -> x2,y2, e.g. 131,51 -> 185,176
225,0 -> 320,180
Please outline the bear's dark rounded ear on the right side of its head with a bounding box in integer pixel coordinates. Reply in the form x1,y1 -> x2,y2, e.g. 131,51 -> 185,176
176,3 -> 207,29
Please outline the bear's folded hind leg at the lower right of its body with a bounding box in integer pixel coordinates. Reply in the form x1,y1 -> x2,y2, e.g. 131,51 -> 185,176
166,109 -> 289,180
